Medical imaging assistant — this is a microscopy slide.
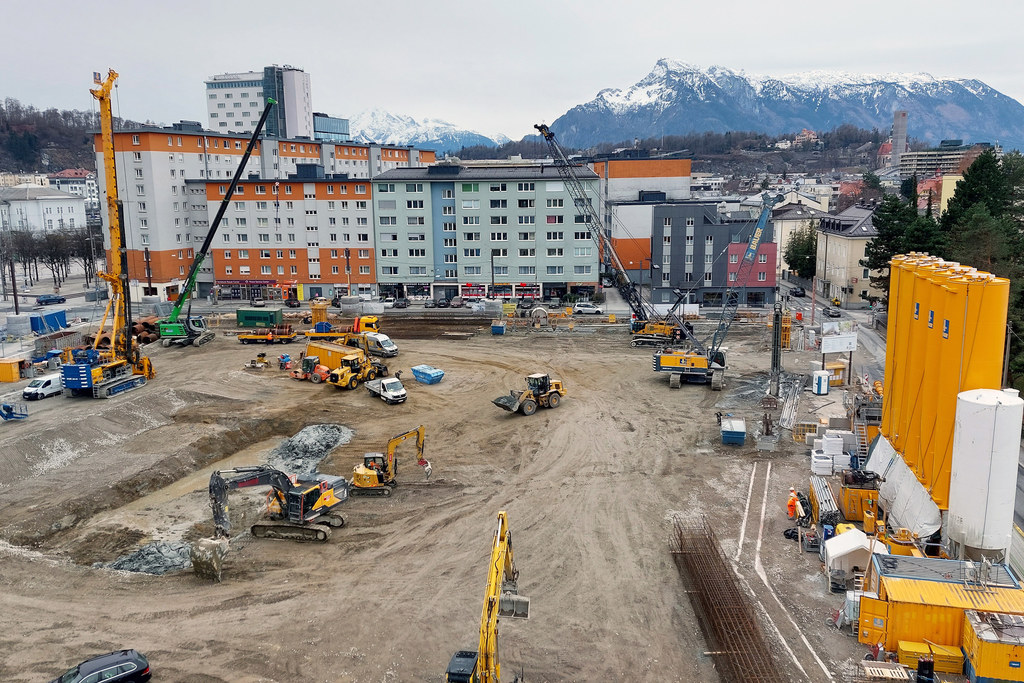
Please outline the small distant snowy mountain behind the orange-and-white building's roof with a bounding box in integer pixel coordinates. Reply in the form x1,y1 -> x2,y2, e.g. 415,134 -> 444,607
348,110 -> 509,153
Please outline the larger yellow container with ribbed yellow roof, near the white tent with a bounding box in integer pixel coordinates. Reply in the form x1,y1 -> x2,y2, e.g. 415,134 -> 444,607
857,577 -> 1024,651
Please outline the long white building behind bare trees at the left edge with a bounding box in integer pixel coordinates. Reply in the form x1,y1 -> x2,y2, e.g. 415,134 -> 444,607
0,185 -> 85,232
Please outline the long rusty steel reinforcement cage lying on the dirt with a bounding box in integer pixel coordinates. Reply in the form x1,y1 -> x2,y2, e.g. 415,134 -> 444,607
672,517 -> 787,683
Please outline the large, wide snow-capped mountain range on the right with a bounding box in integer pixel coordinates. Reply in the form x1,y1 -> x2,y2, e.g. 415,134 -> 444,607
551,59 -> 1024,150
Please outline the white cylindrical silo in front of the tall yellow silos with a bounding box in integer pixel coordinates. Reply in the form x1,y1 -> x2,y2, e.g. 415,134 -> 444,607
947,389 -> 1024,560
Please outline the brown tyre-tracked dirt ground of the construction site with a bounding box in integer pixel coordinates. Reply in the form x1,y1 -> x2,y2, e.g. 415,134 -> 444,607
0,318 -> 864,683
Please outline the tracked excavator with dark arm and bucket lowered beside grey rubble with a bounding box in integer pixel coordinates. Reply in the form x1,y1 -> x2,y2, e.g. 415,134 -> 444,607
190,465 -> 349,581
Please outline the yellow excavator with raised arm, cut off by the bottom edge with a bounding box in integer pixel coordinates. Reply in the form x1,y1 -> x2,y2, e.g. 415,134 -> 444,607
444,510 -> 529,683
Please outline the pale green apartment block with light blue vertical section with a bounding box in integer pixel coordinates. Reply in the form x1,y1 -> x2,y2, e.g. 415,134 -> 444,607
373,163 -> 600,298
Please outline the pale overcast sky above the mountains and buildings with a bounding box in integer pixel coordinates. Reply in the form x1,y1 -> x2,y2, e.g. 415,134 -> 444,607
8,0 -> 1024,139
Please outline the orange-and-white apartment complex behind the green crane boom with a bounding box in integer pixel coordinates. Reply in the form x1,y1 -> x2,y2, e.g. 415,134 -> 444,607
94,122 -> 434,299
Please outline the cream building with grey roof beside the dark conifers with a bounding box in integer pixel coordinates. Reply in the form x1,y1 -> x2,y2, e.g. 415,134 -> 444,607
815,204 -> 882,308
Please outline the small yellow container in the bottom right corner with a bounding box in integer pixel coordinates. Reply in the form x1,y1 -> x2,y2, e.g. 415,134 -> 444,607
963,609 -> 1024,681
